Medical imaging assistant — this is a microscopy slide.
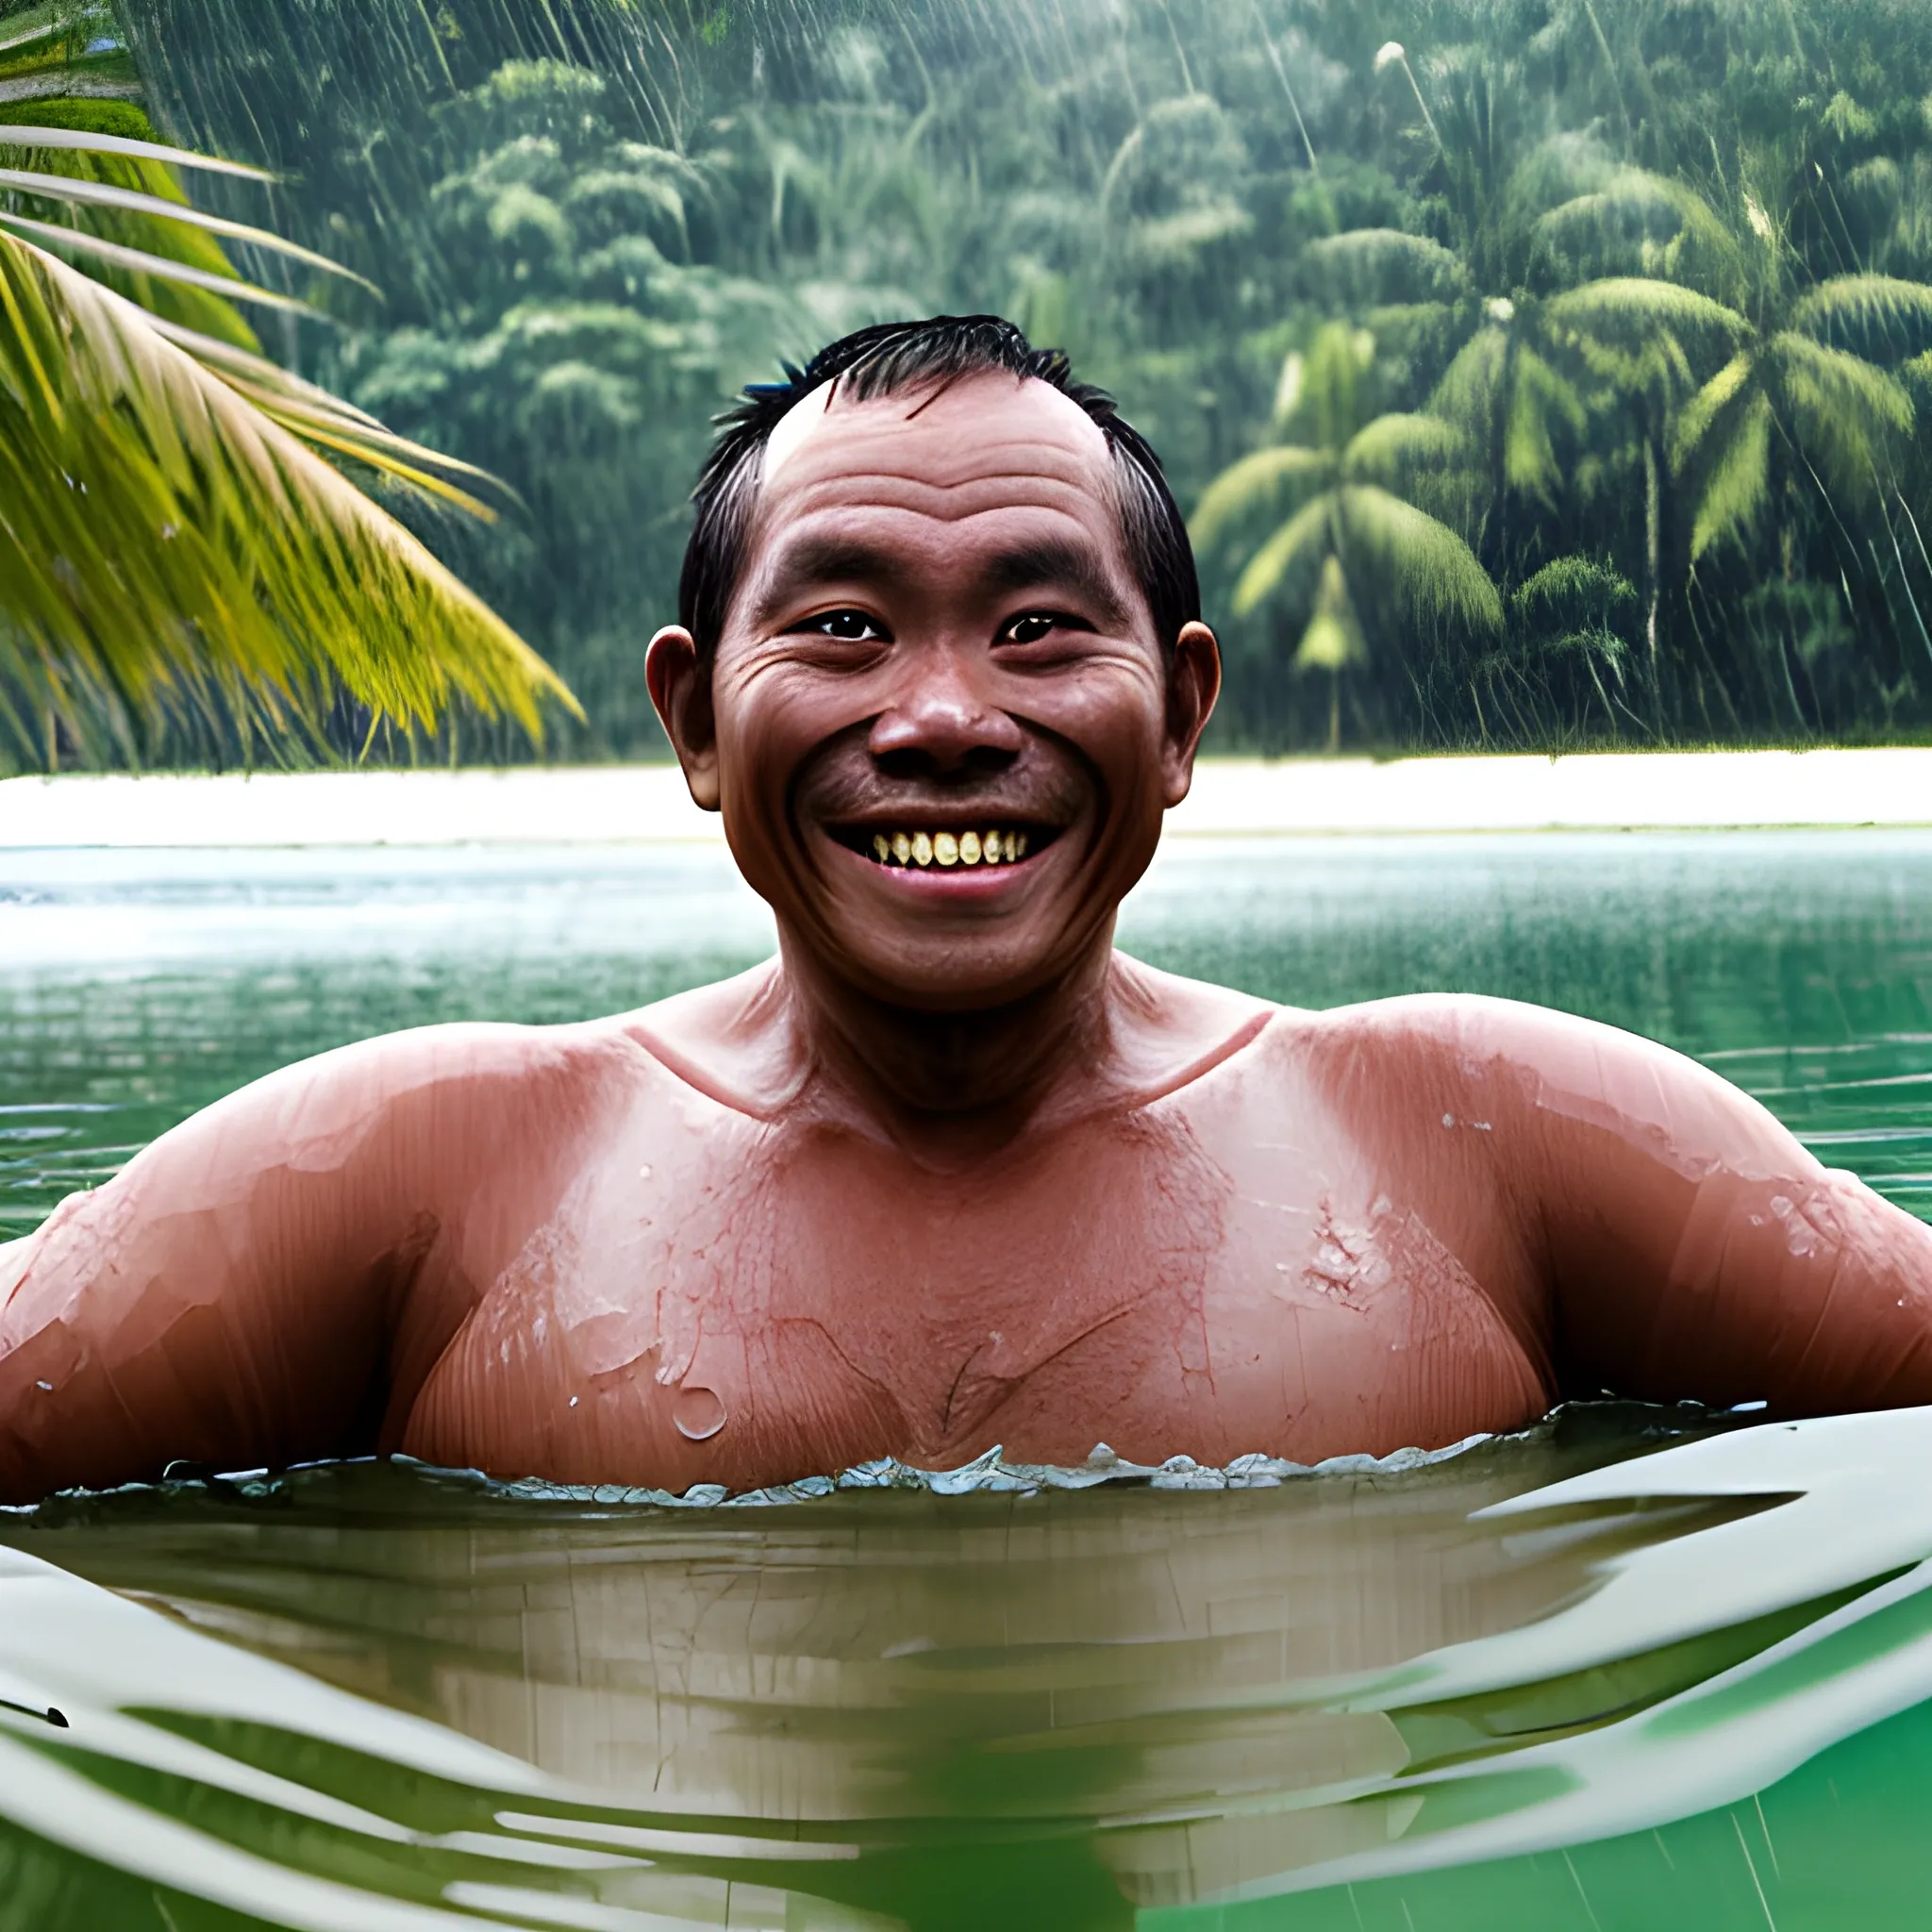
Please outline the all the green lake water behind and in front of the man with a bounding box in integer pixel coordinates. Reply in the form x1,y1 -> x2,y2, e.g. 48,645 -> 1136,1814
0,833 -> 1932,1932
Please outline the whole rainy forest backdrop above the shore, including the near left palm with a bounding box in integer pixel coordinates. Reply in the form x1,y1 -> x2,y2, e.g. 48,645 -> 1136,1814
0,0 -> 1932,771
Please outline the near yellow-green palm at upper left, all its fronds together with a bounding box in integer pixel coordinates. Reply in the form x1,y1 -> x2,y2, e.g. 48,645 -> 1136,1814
0,6 -> 574,767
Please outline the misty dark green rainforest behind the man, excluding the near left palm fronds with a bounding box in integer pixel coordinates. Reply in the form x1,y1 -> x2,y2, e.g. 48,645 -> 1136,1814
83,0 -> 1932,754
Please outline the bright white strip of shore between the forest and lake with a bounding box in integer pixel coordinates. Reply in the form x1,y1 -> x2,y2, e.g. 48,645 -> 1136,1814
0,746 -> 1932,850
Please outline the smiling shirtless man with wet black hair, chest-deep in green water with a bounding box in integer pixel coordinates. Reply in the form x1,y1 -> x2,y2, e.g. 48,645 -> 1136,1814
0,317 -> 1932,1499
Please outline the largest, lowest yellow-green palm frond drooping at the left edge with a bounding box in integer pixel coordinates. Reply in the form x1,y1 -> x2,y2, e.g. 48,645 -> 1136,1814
0,222 -> 574,734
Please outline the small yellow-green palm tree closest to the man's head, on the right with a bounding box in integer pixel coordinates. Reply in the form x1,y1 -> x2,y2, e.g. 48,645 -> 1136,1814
1194,323 -> 1503,750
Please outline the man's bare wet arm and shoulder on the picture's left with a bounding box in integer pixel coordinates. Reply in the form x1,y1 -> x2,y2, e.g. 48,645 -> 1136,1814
0,1025 -> 628,1501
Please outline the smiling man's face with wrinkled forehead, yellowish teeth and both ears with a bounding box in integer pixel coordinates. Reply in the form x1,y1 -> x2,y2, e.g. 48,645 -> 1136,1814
651,375 -> 1217,1010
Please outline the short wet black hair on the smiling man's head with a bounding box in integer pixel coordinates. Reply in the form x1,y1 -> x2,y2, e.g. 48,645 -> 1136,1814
678,315 -> 1202,669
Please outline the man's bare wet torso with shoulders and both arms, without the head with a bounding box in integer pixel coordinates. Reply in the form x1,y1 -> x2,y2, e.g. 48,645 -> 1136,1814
0,958 -> 1932,1497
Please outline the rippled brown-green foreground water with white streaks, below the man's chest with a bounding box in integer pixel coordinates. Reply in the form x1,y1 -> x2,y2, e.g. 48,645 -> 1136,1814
0,1410 -> 1932,1932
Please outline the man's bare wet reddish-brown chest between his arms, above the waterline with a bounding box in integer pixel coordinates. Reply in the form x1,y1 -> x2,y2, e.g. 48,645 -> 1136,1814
409,1108 -> 1541,1488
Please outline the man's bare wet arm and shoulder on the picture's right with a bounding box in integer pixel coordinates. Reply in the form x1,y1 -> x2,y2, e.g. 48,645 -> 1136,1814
1321,997 -> 1932,1414
